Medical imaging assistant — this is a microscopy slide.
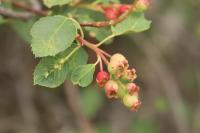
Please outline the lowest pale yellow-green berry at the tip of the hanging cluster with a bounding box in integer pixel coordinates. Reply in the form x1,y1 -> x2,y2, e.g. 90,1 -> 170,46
123,94 -> 141,111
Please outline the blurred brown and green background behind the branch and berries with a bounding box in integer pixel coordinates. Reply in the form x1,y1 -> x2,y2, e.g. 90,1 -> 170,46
0,0 -> 200,133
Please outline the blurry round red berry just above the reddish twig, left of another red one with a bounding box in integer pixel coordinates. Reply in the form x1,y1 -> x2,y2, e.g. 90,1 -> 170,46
104,7 -> 120,20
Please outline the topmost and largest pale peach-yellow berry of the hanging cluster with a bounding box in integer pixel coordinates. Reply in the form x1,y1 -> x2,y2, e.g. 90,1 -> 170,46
108,54 -> 129,77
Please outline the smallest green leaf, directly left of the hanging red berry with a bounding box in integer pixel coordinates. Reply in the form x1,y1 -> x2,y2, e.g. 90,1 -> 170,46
71,64 -> 96,87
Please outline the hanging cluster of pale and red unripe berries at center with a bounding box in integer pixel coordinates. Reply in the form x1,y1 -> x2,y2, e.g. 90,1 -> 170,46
96,54 -> 141,111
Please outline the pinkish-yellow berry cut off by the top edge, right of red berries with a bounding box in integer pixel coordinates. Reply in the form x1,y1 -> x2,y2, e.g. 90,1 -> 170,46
135,0 -> 150,11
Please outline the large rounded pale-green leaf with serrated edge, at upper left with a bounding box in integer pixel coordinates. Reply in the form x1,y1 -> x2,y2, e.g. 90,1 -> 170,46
31,15 -> 77,57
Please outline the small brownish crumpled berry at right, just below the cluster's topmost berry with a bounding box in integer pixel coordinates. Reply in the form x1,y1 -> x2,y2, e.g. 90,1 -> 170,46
122,69 -> 137,82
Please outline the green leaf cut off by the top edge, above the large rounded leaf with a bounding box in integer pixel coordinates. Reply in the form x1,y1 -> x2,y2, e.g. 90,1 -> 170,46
43,0 -> 71,8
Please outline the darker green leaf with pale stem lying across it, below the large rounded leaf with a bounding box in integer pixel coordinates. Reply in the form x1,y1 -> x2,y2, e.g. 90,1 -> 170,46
34,46 -> 88,88
